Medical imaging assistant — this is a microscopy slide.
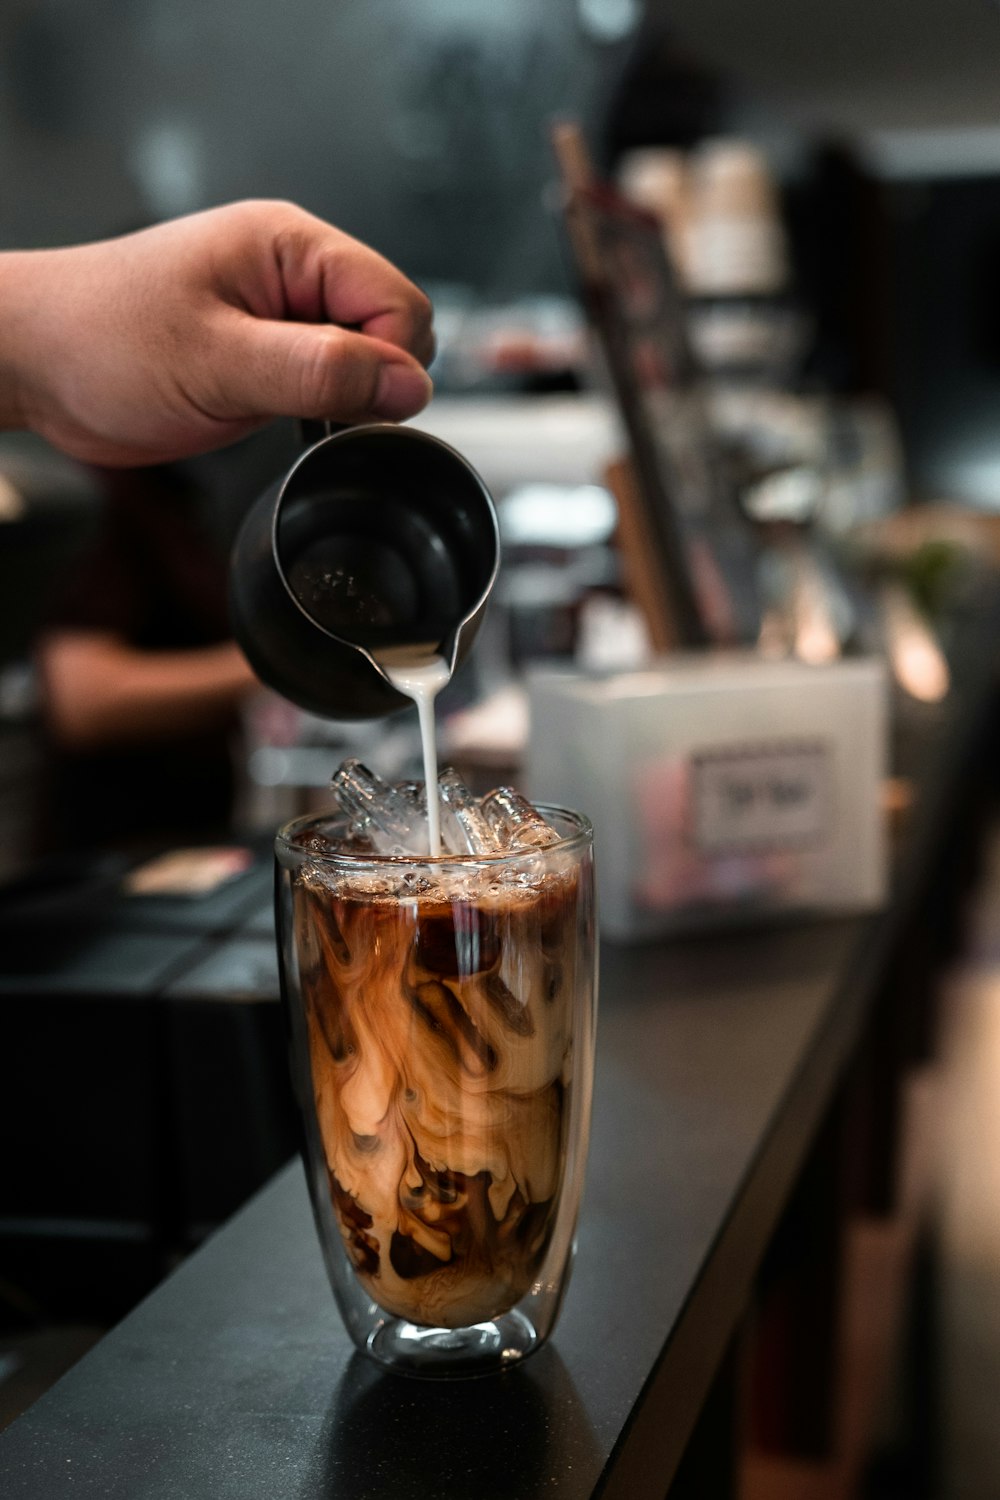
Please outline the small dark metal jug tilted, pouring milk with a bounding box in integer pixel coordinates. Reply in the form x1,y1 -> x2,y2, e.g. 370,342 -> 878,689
231,425 -> 499,719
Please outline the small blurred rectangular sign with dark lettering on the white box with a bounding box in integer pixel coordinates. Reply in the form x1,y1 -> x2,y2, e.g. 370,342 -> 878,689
691,740 -> 832,854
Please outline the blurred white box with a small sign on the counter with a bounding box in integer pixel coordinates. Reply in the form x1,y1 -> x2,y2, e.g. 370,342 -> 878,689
525,653 -> 888,939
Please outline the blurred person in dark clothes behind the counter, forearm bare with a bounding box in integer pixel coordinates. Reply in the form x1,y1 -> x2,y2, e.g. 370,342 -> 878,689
36,465 -> 258,851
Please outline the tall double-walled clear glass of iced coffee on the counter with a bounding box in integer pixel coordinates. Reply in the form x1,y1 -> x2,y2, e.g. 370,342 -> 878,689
276,807 -> 597,1376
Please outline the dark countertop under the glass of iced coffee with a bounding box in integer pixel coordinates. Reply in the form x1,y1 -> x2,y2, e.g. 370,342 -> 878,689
0,921 -> 865,1500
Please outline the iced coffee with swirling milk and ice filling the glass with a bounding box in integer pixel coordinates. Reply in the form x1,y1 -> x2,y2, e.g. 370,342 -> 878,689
294,657 -> 592,1328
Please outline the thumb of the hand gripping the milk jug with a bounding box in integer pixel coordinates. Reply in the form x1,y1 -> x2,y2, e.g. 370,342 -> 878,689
210,315 -> 433,422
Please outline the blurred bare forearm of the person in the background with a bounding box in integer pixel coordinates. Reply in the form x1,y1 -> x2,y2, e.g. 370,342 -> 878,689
39,635 -> 256,749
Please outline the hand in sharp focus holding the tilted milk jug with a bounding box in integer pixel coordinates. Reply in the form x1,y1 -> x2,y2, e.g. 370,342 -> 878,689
0,201 -> 433,465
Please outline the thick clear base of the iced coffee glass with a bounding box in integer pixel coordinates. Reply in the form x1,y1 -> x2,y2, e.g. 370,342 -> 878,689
366,1311 -> 541,1380
